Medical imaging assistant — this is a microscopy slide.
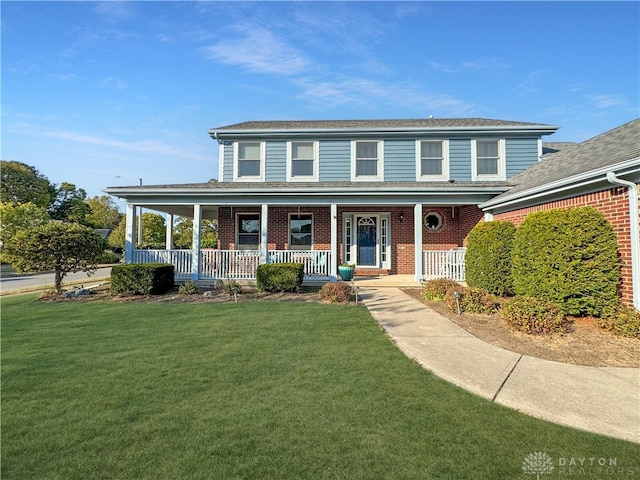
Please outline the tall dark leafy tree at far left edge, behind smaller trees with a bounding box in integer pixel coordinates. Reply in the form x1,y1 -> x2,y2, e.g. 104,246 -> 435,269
0,160 -> 56,208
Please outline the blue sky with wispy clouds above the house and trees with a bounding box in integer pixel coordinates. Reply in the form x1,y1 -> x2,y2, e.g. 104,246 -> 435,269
1,1 -> 640,196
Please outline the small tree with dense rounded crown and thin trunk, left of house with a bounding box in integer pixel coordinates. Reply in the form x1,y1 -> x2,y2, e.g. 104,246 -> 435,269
4,222 -> 105,293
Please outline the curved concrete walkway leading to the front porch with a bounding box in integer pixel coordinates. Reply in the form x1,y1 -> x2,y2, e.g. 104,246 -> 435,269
360,288 -> 640,443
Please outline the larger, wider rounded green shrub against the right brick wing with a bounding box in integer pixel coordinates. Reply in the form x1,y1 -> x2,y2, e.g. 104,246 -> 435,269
512,207 -> 620,316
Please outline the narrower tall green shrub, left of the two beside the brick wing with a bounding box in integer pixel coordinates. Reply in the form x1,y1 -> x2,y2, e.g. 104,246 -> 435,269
465,221 -> 516,297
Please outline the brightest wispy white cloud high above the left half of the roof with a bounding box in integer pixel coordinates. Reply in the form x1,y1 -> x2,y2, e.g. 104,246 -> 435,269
203,24 -> 309,76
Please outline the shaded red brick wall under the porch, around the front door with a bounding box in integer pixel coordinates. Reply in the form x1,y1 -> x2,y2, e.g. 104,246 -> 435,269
218,205 -> 483,275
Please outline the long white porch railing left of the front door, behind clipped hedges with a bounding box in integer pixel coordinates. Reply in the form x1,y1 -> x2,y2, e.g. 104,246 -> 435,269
131,250 -> 331,280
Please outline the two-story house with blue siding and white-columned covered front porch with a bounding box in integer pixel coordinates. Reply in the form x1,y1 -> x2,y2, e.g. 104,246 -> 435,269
105,118 -> 558,281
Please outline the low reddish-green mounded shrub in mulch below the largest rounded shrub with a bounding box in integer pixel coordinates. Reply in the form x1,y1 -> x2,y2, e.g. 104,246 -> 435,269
500,296 -> 568,335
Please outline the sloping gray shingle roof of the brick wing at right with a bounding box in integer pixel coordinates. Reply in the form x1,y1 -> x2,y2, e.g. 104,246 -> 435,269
500,119 -> 640,203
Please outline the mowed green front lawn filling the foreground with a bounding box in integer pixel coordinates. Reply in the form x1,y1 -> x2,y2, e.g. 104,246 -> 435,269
1,295 -> 640,480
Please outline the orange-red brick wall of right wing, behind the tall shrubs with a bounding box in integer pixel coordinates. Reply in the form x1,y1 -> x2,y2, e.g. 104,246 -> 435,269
494,187 -> 633,304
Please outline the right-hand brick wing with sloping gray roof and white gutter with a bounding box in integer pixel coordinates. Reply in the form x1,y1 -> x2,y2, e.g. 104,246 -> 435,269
480,119 -> 640,310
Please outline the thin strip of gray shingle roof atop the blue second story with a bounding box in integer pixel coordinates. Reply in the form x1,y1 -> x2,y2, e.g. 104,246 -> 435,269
213,118 -> 557,130
